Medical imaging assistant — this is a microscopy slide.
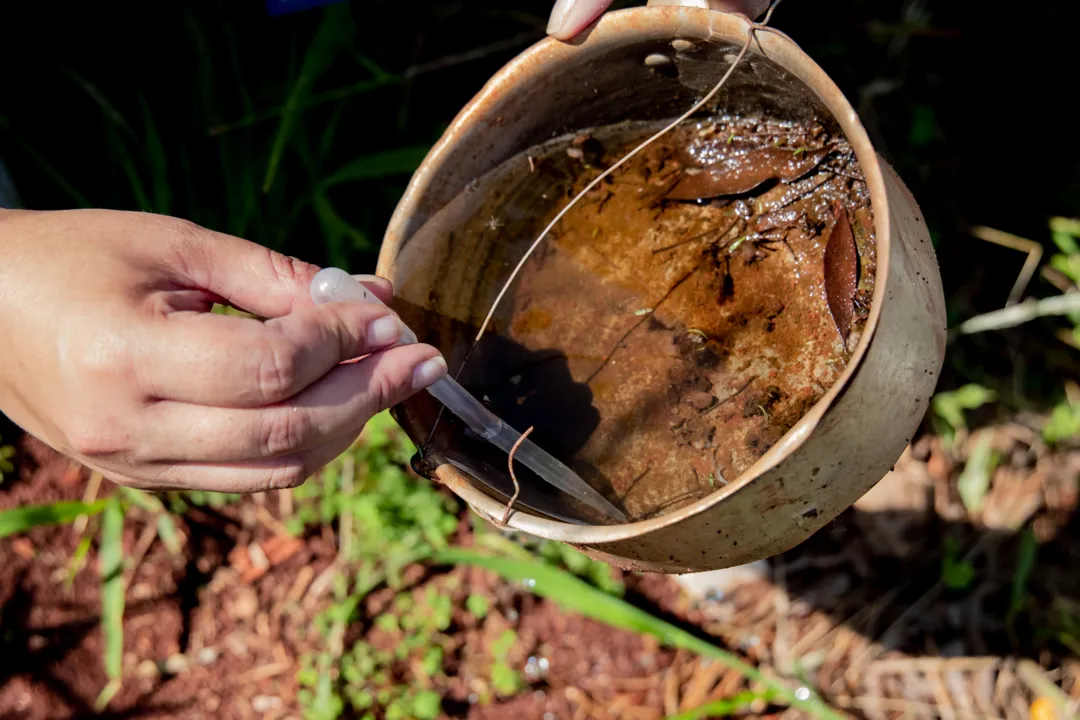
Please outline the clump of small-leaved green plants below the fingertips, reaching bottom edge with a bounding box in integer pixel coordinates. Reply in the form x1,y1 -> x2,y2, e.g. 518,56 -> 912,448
298,412 -> 462,720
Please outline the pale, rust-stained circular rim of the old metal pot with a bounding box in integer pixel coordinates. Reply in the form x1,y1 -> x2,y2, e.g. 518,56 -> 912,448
378,5 -> 892,545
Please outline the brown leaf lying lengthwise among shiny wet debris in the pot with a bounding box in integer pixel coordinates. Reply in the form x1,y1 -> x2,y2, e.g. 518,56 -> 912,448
667,148 -> 828,200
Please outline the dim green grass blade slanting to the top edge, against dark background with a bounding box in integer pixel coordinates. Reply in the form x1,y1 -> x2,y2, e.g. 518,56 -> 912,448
262,4 -> 352,193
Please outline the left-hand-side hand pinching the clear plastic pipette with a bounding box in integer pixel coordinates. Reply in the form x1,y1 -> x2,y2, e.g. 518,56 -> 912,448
0,210 -> 446,492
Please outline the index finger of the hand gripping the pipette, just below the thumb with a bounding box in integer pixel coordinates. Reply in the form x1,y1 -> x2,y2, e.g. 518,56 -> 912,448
133,302 -> 404,407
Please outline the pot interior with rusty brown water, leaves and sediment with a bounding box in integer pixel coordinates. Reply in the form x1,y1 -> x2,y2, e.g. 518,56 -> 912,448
390,23 -> 875,524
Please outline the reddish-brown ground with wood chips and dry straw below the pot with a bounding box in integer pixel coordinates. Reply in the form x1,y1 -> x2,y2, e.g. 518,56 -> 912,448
0,410 -> 1080,720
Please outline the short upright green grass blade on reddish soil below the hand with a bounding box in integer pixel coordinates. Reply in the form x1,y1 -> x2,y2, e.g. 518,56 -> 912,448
97,499 -> 124,709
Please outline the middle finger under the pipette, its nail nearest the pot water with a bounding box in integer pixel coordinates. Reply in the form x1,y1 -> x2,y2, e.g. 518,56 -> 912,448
140,345 -> 446,464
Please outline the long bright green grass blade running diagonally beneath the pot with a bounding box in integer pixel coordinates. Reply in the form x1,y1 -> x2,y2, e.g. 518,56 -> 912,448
432,547 -> 843,720
